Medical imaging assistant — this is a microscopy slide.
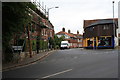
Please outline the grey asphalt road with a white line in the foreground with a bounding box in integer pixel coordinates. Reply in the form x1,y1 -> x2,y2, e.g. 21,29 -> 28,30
3,48 -> 118,79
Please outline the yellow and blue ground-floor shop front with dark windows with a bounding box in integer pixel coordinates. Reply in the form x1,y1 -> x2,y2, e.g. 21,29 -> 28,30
83,36 -> 114,49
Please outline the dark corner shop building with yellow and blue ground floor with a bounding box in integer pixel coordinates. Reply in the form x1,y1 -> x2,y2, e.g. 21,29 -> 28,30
83,18 -> 118,48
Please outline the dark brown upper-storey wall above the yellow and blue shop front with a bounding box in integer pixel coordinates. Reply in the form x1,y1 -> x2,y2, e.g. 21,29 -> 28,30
84,24 -> 113,38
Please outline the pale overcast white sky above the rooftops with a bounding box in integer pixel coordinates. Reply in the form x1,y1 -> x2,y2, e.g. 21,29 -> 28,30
37,0 -> 120,34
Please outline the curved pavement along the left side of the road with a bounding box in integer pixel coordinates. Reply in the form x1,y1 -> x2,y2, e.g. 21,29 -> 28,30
2,50 -> 55,71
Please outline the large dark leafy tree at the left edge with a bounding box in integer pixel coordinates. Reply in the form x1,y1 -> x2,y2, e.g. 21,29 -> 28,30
2,2 -> 36,62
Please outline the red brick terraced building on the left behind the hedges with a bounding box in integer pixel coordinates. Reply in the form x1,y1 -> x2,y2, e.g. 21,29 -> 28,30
20,9 -> 54,41
